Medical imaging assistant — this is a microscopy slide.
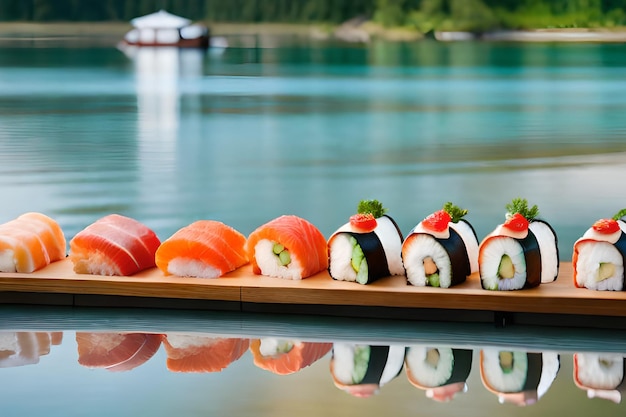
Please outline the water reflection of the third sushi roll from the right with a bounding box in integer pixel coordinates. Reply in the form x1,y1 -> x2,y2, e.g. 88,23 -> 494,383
404,345 -> 473,402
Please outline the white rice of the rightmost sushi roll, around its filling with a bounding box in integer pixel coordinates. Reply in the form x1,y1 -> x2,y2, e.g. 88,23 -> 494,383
576,240 -> 624,291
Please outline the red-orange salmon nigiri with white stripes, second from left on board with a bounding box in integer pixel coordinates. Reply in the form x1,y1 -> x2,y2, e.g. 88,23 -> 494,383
69,214 -> 161,276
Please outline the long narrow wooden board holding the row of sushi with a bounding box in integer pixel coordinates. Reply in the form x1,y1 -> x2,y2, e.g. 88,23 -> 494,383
0,259 -> 626,318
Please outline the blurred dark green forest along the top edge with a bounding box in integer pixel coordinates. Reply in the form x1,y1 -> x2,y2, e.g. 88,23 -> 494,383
0,0 -> 626,32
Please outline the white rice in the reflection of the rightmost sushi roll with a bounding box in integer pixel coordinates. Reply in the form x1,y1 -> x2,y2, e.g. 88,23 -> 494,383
575,353 -> 624,390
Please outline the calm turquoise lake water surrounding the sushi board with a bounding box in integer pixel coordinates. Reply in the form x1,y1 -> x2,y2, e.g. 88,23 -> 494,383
0,40 -> 626,416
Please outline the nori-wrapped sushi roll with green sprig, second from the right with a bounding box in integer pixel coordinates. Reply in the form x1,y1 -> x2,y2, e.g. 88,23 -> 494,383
478,198 -> 559,290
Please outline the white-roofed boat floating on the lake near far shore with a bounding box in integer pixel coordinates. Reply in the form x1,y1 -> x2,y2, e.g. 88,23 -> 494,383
121,10 -> 210,48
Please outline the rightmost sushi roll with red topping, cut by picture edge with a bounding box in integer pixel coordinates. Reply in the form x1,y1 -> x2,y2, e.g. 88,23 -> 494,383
572,209 -> 626,291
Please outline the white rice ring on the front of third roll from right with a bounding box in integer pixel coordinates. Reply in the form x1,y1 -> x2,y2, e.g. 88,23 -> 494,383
402,233 -> 452,288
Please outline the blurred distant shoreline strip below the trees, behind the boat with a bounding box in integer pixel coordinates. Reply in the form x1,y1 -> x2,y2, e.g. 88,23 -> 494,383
0,22 -> 626,43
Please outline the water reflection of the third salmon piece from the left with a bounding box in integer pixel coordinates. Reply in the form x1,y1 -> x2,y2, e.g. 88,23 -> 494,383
163,333 -> 250,372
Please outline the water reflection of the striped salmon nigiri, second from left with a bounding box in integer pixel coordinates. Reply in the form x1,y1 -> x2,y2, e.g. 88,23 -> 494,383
76,332 -> 162,372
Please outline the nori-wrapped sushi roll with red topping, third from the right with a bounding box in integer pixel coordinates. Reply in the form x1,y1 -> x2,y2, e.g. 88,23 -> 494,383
402,202 -> 478,288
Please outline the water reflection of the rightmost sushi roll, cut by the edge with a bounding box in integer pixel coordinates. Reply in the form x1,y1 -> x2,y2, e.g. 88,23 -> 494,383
574,353 -> 626,404
